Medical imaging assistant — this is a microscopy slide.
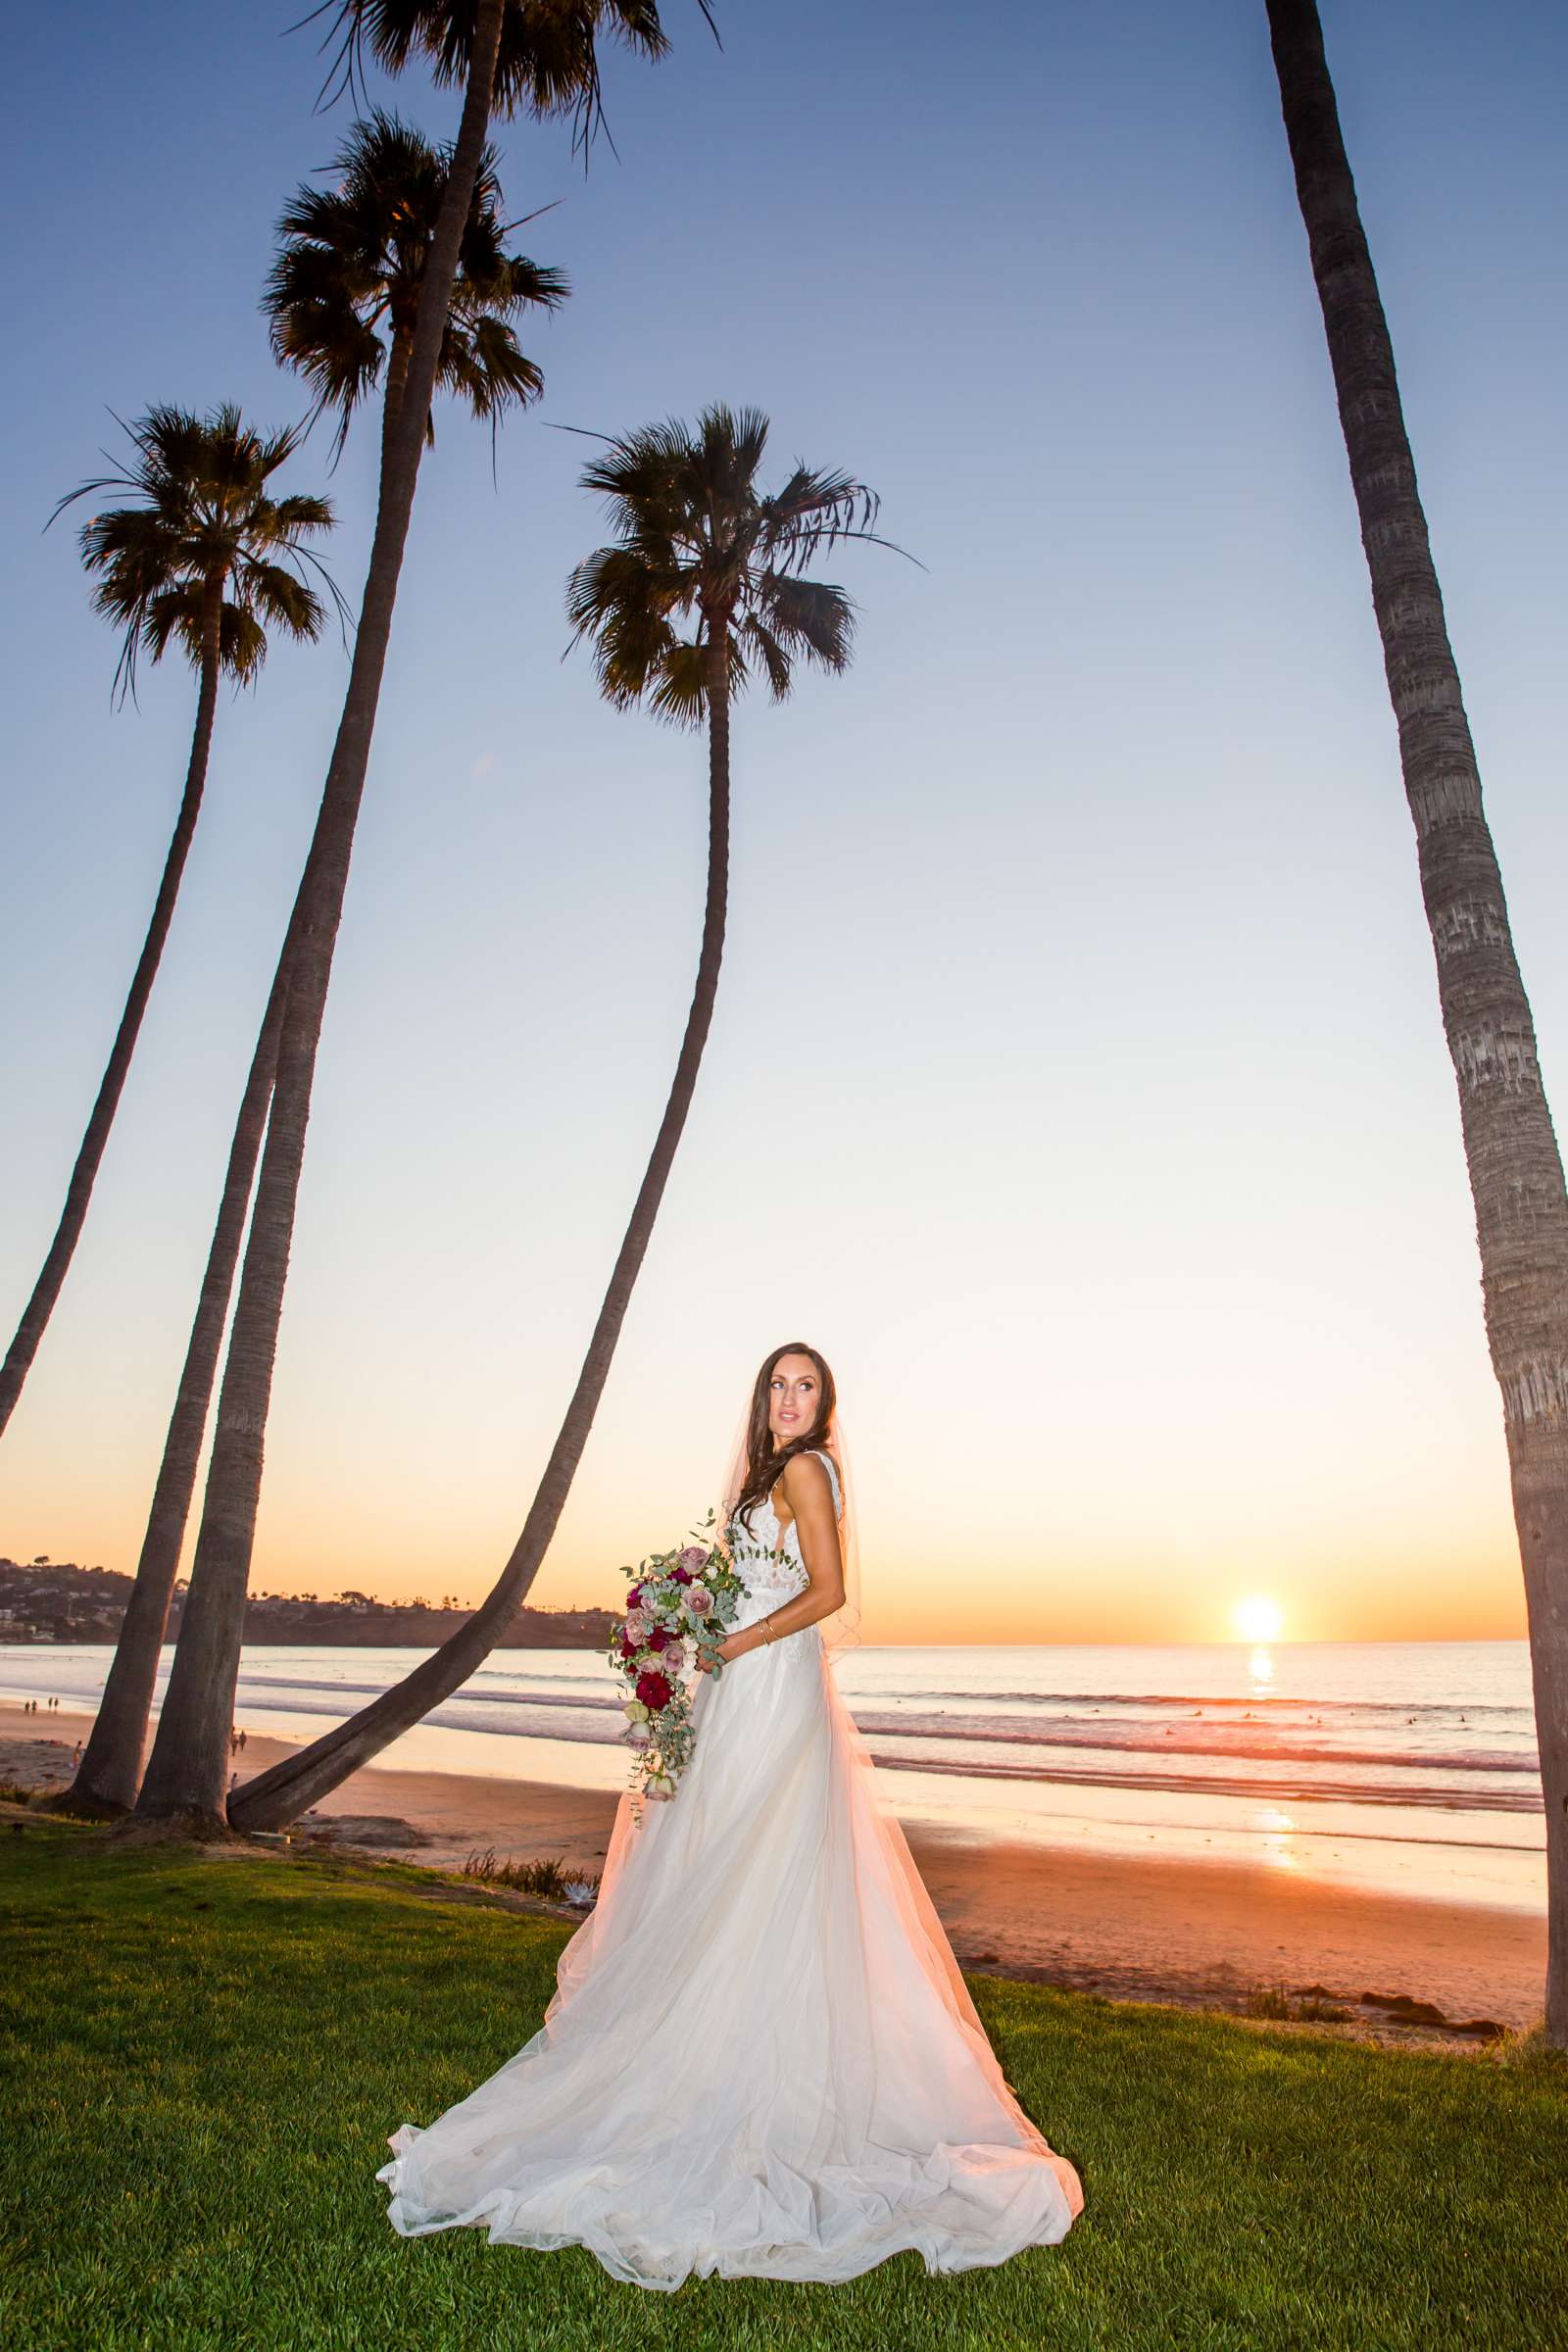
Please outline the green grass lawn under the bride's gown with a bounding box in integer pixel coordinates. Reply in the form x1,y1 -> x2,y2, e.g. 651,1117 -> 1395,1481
0,1821 -> 1568,2352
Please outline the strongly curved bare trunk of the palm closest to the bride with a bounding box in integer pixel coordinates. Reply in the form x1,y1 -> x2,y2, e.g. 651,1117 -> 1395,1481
228,625 -> 729,1830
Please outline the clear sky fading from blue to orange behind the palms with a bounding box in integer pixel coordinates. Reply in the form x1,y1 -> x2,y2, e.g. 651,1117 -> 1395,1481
0,0 -> 1568,1640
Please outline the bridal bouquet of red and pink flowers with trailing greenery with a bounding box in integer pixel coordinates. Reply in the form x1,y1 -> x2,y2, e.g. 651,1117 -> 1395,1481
609,1512 -> 745,1797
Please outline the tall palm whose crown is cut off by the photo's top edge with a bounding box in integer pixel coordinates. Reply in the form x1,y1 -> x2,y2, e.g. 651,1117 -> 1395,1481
139,0 -> 665,1835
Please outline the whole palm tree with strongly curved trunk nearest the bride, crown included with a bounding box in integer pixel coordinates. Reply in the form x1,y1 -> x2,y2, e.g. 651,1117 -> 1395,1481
228,407 -> 877,1830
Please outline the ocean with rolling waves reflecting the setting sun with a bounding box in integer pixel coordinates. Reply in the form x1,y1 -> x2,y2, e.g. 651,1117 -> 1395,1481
0,1642 -> 1544,1910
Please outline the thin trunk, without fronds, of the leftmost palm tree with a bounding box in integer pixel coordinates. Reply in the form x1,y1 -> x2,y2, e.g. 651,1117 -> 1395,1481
0,571 -> 223,1430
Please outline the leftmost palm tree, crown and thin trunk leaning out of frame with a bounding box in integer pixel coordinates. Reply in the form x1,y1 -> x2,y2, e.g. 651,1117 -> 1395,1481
0,405 -> 331,1430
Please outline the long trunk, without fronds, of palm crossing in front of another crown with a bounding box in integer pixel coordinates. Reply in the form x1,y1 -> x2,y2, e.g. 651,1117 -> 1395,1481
139,0 -> 503,1835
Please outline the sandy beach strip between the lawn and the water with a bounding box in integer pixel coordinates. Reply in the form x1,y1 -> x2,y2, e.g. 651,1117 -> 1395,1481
0,1705 -> 1546,2033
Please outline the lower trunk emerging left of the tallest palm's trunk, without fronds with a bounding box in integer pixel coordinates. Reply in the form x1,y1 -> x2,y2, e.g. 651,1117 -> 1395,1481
54,971 -> 284,1816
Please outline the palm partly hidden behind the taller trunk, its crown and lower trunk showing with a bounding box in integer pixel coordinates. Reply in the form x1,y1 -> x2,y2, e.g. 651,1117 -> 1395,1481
61,91 -> 566,1813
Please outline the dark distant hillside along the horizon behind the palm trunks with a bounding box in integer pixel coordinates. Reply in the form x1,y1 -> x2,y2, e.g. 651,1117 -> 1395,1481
0,1559 -> 615,1648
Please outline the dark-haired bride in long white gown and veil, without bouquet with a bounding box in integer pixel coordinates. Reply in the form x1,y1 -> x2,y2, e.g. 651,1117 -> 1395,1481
376,1346 -> 1084,2288
